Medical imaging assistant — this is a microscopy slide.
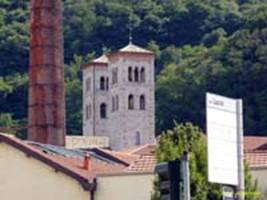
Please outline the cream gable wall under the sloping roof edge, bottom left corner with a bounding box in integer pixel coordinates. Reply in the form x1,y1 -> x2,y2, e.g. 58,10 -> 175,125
0,143 -> 89,200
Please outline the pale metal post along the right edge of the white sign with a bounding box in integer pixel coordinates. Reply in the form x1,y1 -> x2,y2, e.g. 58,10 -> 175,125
237,99 -> 245,200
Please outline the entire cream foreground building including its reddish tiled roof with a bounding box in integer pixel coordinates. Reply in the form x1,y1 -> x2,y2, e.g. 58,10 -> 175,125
0,134 -> 156,200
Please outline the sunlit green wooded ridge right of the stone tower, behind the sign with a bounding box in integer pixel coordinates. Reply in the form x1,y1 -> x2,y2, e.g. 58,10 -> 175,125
157,28 -> 267,135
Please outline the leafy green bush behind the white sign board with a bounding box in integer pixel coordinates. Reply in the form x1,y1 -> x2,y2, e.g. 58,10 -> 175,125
152,123 -> 258,200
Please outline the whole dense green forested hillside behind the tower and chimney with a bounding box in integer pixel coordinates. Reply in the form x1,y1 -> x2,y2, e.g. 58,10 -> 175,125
0,0 -> 267,135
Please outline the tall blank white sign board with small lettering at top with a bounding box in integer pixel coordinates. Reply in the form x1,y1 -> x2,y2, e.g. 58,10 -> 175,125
206,93 -> 240,186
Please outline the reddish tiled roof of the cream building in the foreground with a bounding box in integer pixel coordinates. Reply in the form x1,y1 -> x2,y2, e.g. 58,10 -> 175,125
0,134 -> 156,190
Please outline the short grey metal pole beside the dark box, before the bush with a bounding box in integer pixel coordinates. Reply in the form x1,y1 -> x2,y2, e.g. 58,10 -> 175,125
183,152 -> 191,200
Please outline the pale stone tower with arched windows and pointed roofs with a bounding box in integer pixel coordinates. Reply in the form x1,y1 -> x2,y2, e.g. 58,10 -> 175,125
83,43 -> 155,150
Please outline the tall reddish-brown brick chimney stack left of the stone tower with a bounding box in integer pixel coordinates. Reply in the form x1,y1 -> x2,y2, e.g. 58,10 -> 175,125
28,0 -> 65,146
